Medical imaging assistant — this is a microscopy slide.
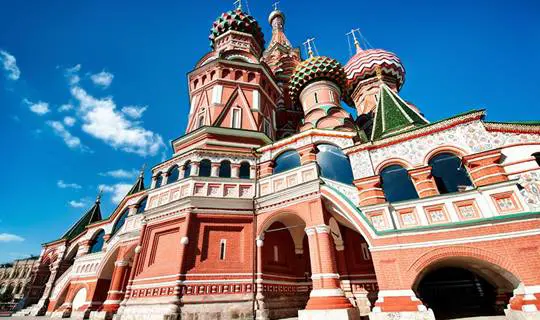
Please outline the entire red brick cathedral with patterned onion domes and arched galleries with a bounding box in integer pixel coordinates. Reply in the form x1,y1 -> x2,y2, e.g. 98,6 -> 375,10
13,4 -> 540,320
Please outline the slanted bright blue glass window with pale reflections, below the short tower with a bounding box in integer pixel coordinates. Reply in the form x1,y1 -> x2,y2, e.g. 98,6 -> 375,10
317,144 -> 354,184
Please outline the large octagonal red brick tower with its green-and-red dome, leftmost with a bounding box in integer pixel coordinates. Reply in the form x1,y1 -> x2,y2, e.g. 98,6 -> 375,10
186,6 -> 282,139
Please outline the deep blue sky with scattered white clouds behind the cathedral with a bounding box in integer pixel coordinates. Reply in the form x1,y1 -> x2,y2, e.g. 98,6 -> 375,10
0,0 -> 540,262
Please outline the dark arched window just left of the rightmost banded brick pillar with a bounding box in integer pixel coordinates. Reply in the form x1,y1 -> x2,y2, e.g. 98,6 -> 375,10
429,152 -> 473,194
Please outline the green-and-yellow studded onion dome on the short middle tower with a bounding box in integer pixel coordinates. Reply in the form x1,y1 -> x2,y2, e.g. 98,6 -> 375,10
289,56 -> 351,104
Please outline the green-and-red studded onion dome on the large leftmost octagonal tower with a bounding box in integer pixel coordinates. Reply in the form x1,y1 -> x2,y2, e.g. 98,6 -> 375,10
208,8 -> 264,49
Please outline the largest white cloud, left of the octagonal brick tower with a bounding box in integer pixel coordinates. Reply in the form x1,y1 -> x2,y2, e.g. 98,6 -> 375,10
71,86 -> 164,156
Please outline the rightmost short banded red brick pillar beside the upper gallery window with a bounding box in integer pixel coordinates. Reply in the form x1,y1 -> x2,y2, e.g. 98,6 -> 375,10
463,149 -> 508,187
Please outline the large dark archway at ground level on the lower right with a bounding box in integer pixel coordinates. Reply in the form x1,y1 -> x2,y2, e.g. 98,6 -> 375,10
415,258 -> 519,319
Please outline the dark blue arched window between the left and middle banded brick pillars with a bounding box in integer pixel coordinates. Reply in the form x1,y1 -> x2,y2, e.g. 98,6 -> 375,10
381,164 -> 418,202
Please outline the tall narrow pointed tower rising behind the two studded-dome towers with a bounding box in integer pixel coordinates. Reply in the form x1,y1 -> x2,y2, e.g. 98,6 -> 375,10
261,3 -> 304,138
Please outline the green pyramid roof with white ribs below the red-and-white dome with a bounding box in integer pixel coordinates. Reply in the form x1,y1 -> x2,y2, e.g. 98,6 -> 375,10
371,80 -> 429,140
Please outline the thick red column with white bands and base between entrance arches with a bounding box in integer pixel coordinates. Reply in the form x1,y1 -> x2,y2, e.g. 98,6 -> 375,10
298,224 -> 360,320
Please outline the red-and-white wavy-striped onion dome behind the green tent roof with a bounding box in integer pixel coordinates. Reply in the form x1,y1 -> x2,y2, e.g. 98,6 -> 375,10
343,47 -> 405,91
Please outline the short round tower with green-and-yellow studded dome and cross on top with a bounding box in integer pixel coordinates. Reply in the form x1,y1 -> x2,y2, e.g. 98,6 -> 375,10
289,40 -> 355,131
